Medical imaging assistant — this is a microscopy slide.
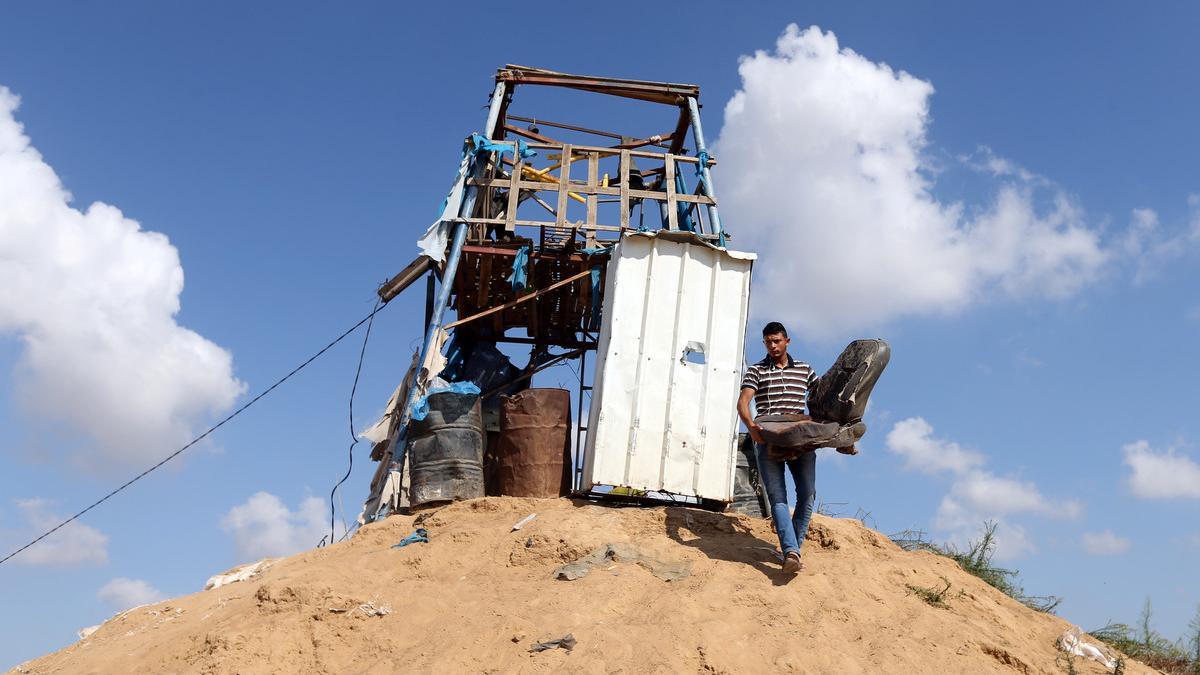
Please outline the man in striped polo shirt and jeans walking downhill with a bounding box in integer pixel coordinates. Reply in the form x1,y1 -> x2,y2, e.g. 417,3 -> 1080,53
738,321 -> 817,574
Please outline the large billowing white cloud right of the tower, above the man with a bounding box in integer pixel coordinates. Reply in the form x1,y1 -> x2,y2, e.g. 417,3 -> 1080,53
715,25 -> 1110,339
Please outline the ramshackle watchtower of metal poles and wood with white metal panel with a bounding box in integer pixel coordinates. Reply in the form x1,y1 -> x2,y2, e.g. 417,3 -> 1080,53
364,65 -> 754,520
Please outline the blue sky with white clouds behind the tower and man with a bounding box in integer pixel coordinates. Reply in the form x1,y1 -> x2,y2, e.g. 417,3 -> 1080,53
0,2 -> 1200,665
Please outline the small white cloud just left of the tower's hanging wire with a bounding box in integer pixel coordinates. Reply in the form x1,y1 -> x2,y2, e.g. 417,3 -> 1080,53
221,492 -> 333,561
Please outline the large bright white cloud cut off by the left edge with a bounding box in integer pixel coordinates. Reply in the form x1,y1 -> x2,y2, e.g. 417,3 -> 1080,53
0,86 -> 244,467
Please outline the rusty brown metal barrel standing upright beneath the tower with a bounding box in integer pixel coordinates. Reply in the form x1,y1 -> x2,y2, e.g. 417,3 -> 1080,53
488,389 -> 571,497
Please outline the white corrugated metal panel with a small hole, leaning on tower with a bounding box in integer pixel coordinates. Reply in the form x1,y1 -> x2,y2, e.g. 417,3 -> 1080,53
583,232 -> 755,501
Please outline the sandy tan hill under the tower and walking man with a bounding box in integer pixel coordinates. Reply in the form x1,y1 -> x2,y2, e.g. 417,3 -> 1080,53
7,497 -> 1151,674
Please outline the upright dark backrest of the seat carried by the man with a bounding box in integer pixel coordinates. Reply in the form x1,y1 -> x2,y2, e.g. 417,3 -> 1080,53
809,340 -> 892,425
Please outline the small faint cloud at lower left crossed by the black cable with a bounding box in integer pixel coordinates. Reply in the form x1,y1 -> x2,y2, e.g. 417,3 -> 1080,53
5,498 -> 108,567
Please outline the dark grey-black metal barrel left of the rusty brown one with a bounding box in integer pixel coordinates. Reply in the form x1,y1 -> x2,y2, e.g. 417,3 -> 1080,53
408,392 -> 484,507
